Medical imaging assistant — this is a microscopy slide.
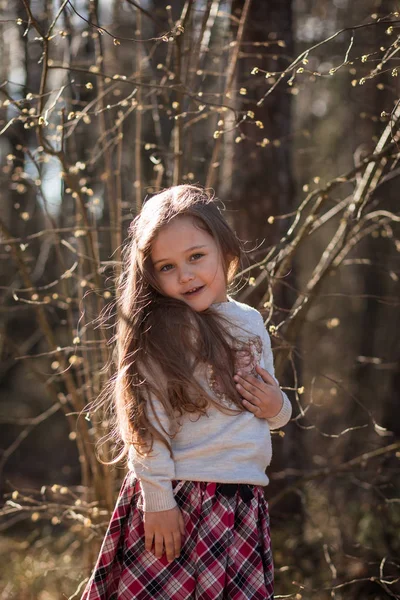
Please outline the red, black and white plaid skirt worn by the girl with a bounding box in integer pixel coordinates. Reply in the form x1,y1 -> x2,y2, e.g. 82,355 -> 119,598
81,472 -> 273,600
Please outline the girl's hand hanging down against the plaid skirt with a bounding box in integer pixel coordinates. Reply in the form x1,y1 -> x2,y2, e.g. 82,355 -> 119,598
144,506 -> 185,562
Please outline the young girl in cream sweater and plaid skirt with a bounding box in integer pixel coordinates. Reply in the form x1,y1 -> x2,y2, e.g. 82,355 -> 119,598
83,185 -> 291,600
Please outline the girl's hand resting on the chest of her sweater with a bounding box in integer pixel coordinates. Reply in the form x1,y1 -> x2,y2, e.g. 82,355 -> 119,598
234,365 -> 283,419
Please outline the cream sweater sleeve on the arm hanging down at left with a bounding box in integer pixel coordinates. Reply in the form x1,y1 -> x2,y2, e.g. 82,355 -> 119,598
128,396 -> 177,512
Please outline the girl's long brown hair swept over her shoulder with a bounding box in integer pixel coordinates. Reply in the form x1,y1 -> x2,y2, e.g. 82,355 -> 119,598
115,185 -> 244,458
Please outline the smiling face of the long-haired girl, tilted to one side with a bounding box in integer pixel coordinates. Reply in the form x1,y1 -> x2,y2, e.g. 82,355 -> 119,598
151,216 -> 227,312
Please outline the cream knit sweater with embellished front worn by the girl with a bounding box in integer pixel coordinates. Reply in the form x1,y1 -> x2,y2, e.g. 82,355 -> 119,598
129,298 -> 292,512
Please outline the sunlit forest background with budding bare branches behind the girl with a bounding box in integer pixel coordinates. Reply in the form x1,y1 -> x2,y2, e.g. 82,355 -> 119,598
0,0 -> 400,600
